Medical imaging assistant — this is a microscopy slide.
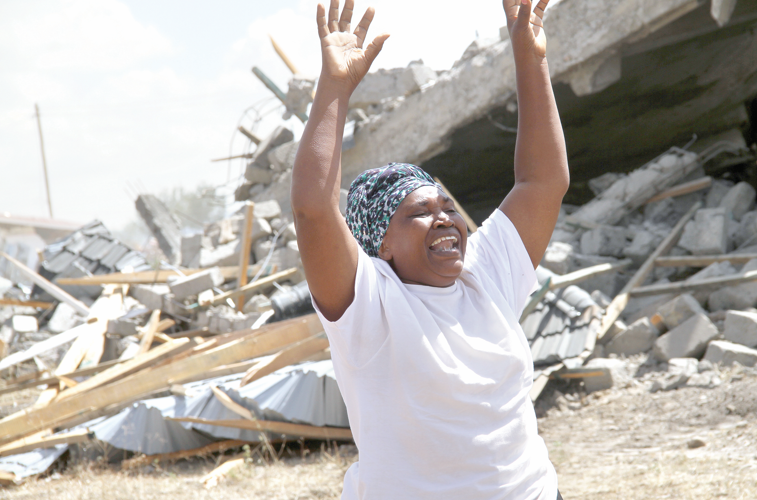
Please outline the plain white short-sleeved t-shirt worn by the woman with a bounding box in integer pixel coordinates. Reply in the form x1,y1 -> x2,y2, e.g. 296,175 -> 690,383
316,210 -> 557,500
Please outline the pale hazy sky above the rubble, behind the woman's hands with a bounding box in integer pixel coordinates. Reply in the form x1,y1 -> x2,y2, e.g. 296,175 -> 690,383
0,0 -> 505,234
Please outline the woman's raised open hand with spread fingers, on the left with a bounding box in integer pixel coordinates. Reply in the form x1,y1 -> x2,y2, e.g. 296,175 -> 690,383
317,0 -> 389,94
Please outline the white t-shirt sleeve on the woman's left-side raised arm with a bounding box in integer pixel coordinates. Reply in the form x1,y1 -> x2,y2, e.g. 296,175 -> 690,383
311,245 -> 387,368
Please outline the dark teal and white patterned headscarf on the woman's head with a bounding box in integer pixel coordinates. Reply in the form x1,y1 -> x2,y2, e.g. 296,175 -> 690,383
347,163 -> 441,257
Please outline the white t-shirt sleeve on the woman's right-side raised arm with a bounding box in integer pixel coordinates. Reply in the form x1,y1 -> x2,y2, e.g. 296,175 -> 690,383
465,209 -> 537,314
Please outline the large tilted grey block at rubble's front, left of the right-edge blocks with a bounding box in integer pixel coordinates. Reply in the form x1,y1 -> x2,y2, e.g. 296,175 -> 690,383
654,314 -> 719,361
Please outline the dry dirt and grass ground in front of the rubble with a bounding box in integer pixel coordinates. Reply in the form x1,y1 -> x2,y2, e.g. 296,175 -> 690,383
0,368 -> 757,500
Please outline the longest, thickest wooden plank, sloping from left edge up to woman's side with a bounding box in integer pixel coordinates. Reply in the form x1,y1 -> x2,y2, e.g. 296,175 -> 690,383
0,316 -> 317,444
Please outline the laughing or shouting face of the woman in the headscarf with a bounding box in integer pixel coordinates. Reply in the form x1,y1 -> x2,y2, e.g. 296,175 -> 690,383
379,186 -> 468,287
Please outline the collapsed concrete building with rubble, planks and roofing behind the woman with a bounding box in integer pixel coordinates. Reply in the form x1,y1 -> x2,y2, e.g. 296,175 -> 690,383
0,0 -> 757,488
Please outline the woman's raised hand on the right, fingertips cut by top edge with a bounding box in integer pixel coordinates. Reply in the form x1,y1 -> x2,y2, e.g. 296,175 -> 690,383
502,0 -> 549,62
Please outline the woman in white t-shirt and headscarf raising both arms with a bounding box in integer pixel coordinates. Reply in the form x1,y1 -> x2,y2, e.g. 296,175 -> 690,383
292,0 -> 569,500
